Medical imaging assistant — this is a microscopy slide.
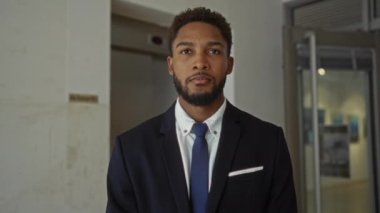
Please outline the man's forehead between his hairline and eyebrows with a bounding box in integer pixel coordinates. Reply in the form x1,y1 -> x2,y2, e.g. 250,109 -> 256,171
173,22 -> 226,44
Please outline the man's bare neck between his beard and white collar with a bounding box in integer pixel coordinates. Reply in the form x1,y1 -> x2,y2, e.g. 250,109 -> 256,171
179,94 -> 224,122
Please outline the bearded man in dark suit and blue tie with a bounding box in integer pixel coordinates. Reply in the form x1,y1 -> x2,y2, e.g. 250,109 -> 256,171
107,8 -> 297,213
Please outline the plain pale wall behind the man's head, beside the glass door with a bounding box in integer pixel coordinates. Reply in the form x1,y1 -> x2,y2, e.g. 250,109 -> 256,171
119,0 -> 284,126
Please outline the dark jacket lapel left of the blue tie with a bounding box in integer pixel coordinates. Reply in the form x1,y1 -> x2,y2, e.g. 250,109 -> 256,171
160,105 -> 190,213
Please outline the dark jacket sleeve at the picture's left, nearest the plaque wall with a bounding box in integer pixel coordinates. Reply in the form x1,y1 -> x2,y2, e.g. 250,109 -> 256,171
106,139 -> 138,213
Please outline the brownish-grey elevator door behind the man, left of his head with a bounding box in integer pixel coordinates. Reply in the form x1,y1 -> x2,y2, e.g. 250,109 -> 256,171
110,16 -> 176,144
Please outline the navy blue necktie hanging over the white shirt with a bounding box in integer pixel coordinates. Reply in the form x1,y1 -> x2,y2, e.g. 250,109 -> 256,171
190,123 -> 208,213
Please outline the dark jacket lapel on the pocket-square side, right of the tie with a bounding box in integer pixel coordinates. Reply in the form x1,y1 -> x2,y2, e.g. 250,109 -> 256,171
208,102 -> 240,213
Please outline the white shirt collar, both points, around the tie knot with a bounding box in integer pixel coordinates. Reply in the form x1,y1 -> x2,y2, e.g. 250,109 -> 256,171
175,98 -> 227,136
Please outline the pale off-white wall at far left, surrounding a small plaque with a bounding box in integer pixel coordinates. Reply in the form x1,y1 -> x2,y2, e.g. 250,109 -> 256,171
0,0 -> 110,213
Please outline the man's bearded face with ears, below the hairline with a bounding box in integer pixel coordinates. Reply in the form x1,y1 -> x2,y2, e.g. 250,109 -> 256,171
167,22 -> 233,106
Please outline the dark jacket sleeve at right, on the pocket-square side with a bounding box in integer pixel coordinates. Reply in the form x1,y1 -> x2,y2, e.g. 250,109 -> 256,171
268,129 -> 297,213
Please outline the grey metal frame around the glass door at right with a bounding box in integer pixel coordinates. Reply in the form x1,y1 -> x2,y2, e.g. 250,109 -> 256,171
283,26 -> 380,212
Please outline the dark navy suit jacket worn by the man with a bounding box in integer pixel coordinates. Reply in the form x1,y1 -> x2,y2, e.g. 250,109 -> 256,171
106,103 -> 297,213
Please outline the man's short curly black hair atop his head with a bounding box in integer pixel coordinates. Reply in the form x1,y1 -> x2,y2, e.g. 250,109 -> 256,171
168,7 -> 232,55
